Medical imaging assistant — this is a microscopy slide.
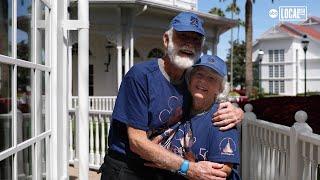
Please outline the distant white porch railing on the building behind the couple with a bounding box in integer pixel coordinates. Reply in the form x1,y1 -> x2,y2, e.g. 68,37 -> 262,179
70,96 -> 116,112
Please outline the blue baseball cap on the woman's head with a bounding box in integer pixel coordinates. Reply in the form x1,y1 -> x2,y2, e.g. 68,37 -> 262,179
193,55 -> 227,78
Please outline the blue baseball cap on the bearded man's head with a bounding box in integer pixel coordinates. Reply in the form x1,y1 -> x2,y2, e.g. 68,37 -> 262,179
170,12 -> 205,36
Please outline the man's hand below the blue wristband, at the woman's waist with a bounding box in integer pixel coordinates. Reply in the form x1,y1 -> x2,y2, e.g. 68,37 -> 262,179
187,161 -> 227,180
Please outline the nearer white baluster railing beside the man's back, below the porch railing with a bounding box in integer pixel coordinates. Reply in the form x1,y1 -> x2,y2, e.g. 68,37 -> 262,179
69,110 -> 111,170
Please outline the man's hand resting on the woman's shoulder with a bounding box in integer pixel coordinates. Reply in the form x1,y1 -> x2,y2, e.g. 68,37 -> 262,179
212,102 -> 244,131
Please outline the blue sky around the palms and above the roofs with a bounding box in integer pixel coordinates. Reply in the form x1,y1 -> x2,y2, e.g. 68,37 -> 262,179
198,0 -> 320,58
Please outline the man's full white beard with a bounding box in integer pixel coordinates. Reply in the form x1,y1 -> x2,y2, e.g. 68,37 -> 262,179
168,38 -> 200,69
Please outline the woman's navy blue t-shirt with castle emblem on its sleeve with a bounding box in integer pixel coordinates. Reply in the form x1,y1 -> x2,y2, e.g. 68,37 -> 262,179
167,104 -> 240,164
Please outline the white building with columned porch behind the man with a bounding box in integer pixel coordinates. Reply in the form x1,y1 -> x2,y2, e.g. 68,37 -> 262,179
70,0 -> 235,96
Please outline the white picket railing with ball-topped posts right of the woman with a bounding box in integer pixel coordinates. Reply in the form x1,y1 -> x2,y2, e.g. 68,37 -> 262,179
241,104 -> 320,180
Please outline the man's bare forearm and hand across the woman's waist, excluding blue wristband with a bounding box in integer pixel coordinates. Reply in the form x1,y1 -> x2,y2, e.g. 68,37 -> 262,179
128,127 -> 227,180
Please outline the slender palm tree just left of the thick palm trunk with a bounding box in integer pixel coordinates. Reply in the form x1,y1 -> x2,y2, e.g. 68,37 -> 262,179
226,0 -> 240,90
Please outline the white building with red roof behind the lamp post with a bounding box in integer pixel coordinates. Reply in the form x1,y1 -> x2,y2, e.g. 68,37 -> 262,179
252,17 -> 320,96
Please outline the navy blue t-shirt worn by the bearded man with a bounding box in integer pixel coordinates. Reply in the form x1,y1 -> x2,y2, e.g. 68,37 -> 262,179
108,59 -> 188,154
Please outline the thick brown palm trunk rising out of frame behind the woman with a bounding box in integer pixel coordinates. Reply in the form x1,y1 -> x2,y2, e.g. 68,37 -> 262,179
245,0 -> 253,97
